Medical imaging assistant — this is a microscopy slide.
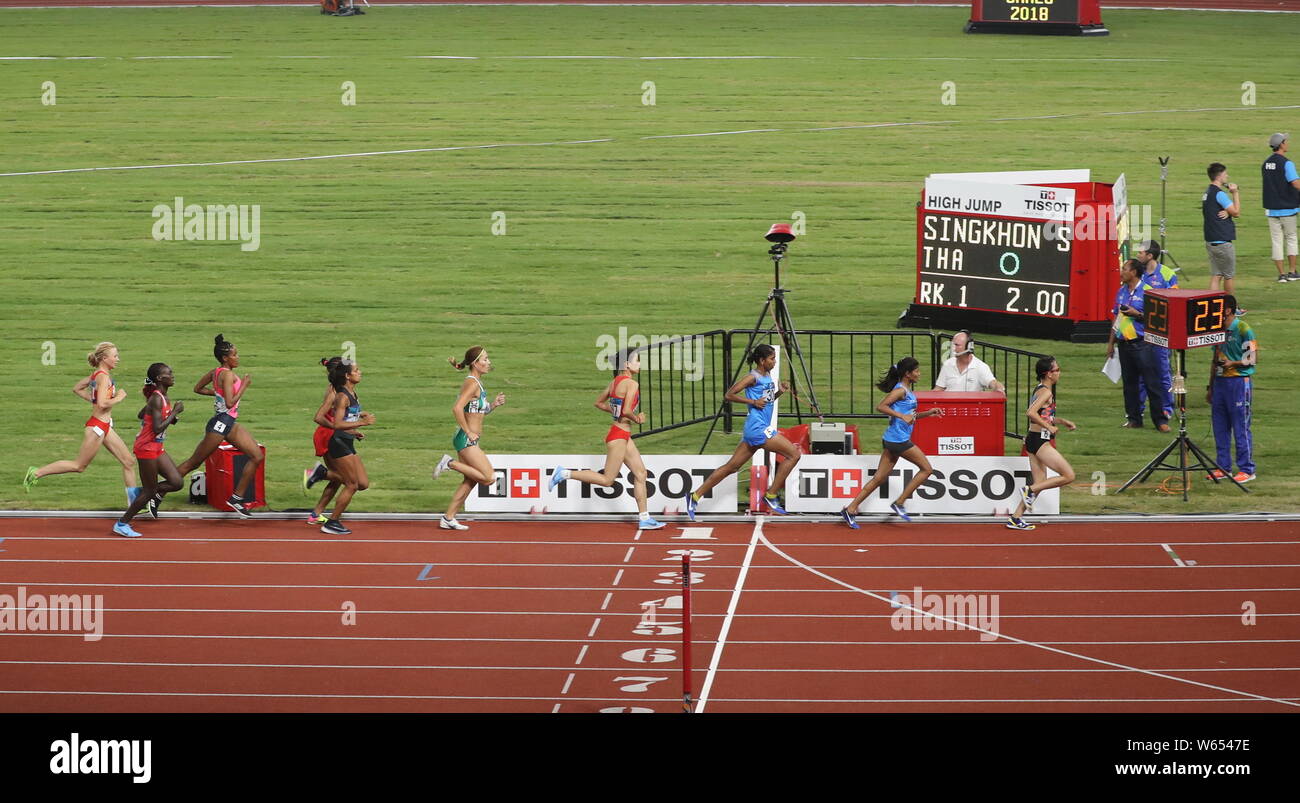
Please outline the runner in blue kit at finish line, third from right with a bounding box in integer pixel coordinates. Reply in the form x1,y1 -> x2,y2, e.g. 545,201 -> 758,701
686,343 -> 800,521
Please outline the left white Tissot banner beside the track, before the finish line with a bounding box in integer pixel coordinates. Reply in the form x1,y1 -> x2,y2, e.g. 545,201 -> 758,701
465,455 -> 738,515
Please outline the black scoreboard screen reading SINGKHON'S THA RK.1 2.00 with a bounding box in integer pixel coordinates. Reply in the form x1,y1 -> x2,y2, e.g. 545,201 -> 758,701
917,212 -> 1073,317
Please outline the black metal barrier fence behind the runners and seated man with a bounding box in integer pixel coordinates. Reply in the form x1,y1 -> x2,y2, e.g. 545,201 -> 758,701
632,329 -> 1047,446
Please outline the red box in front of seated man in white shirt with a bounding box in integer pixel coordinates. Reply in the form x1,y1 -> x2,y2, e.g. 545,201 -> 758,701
911,390 -> 1006,457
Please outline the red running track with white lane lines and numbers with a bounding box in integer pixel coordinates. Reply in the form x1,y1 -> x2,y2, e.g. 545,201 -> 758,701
0,517 -> 1300,713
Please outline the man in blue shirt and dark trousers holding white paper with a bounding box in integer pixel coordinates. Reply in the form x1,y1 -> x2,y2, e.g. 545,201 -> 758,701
1106,260 -> 1170,433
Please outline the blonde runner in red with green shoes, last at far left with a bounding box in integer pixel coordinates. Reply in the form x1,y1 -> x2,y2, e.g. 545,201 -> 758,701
22,340 -> 140,503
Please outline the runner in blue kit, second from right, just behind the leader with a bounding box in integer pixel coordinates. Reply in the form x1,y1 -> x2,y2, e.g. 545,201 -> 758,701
840,357 -> 944,530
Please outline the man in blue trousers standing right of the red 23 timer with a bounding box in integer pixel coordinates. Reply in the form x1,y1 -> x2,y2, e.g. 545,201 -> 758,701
1205,296 -> 1258,482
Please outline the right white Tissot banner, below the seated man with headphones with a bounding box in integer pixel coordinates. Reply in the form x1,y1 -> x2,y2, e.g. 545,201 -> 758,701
785,455 -> 1061,516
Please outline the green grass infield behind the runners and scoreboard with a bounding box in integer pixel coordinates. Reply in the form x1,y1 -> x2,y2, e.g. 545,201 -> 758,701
0,6 -> 1300,512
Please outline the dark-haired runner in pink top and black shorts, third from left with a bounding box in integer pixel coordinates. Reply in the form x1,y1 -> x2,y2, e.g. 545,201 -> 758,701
177,335 -> 261,518
